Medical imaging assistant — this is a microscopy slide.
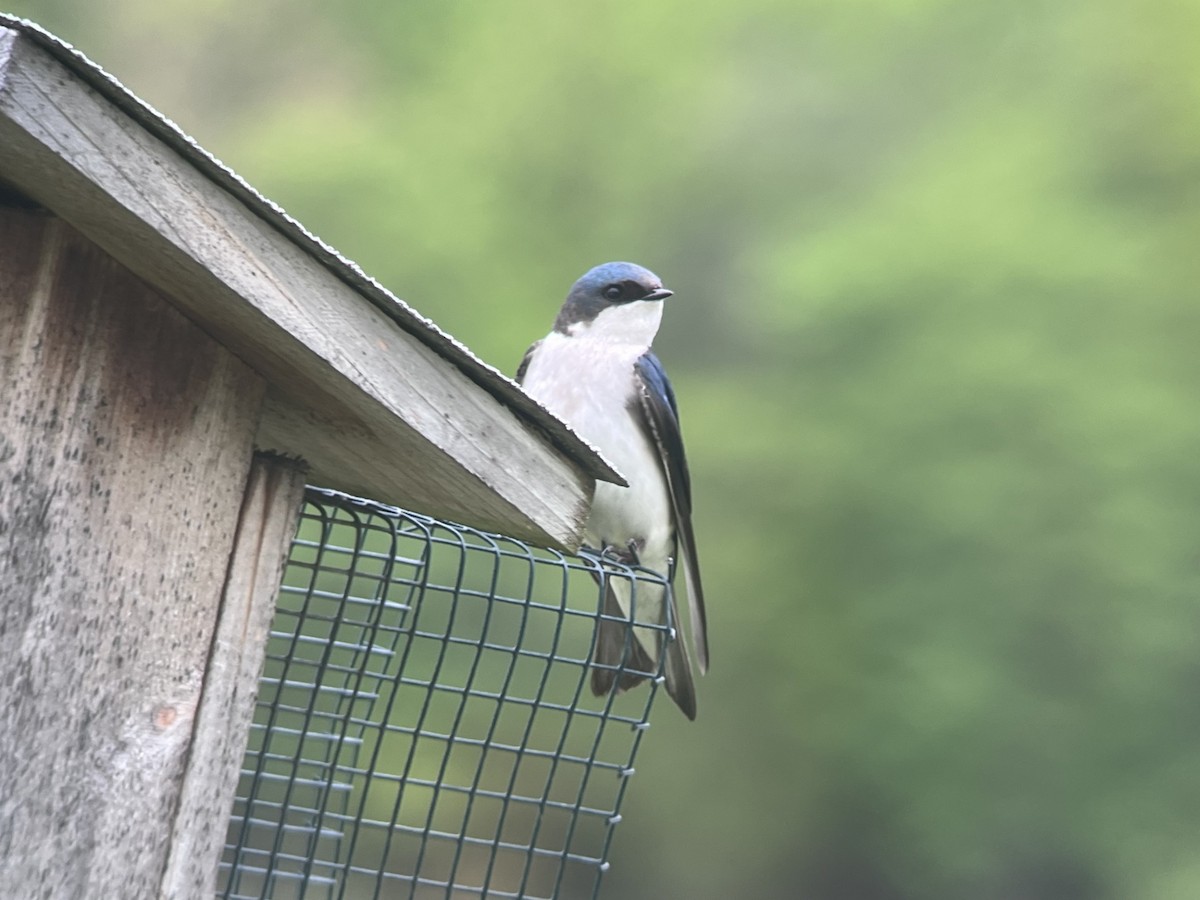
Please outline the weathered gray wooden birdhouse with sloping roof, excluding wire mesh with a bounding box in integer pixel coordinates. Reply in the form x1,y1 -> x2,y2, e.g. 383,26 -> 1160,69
0,18 -> 618,898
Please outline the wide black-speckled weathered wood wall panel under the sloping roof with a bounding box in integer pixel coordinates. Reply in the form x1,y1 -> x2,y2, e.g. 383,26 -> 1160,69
0,208 -> 263,900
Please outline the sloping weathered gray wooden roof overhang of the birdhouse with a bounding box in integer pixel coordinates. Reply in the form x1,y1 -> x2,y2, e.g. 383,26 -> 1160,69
0,22 -> 617,546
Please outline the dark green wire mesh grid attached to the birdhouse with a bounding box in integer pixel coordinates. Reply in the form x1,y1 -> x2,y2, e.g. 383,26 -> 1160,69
218,488 -> 673,900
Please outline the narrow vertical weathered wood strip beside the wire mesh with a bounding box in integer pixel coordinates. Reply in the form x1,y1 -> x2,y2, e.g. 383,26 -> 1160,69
161,455 -> 305,900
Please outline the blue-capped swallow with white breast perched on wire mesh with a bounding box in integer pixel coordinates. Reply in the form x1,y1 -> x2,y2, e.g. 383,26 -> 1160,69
517,263 -> 708,719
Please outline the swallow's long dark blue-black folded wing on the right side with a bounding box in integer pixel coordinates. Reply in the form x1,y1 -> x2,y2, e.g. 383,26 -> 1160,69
634,353 -> 708,672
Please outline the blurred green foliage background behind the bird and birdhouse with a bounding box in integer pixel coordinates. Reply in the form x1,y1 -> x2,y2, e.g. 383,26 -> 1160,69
8,0 -> 1200,900
